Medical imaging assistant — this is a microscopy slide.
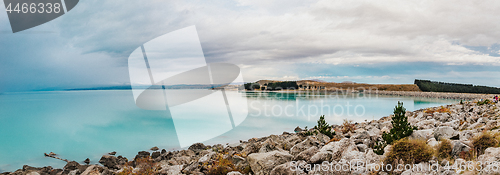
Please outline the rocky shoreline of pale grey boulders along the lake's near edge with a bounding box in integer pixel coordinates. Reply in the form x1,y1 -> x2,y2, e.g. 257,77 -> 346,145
2,99 -> 500,175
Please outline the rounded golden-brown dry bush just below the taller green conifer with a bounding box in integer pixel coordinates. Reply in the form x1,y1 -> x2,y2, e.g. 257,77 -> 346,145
384,138 -> 434,167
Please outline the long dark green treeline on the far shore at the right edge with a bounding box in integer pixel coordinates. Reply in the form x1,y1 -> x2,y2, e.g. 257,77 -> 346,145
415,79 -> 500,94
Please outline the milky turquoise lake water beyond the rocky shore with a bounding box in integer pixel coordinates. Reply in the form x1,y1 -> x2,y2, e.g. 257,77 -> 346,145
0,90 -> 457,172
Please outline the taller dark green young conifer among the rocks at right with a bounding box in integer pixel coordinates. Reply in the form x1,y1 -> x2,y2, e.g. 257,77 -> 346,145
382,102 -> 417,144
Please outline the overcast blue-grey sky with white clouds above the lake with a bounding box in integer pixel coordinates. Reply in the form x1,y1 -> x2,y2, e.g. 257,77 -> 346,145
0,0 -> 500,92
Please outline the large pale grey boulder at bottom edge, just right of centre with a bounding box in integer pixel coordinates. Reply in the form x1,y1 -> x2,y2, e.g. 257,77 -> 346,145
247,151 -> 293,175
